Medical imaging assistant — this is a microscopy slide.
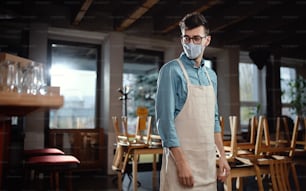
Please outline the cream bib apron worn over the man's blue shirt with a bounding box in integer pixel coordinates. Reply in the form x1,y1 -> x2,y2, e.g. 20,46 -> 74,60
160,59 -> 217,191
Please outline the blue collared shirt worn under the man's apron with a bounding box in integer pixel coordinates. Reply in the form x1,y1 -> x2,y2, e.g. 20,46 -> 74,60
155,53 -> 221,147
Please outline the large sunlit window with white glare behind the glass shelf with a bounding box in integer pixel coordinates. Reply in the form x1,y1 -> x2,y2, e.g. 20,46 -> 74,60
49,42 -> 99,129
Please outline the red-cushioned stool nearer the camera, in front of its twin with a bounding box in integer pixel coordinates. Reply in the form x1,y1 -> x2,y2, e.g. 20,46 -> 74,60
25,155 -> 80,190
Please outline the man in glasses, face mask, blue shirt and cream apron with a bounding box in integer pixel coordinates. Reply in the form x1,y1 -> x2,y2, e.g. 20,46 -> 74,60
156,13 -> 230,191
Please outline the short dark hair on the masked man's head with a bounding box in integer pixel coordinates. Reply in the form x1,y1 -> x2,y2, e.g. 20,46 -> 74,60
179,12 -> 209,35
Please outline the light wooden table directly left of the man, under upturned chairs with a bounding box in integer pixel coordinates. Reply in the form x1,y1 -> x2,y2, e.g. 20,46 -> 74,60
131,147 -> 163,191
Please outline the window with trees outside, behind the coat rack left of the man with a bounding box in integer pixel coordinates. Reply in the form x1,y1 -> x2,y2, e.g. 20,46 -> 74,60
122,48 -> 163,132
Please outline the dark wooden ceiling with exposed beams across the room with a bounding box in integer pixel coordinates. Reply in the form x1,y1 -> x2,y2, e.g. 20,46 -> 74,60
0,0 -> 306,62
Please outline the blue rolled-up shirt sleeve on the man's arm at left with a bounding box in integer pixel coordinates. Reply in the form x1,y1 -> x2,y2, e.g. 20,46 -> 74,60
155,64 -> 179,147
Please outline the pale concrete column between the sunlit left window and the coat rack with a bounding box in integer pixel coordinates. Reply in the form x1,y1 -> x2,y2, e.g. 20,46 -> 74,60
98,32 -> 124,174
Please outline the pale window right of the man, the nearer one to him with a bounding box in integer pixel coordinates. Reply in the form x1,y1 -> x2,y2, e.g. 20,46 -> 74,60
239,52 -> 266,129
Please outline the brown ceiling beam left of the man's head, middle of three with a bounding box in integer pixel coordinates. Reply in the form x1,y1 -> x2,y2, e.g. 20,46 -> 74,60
116,0 -> 159,31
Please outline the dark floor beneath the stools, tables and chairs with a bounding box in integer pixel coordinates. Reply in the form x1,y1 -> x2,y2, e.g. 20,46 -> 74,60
1,164 -> 306,191
